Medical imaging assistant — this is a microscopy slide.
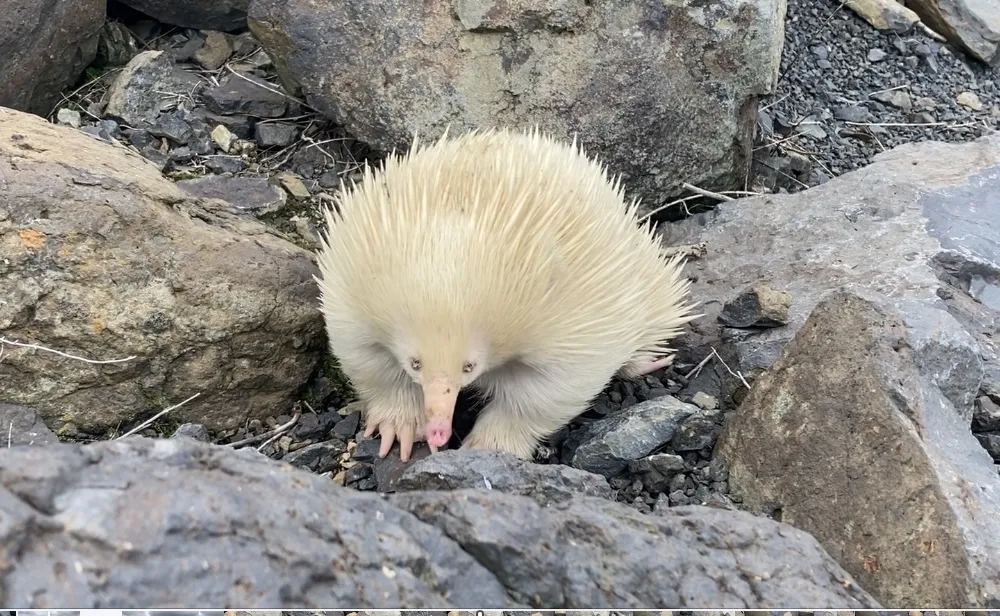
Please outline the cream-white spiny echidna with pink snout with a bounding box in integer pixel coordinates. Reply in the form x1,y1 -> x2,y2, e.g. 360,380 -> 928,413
318,130 -> 699,460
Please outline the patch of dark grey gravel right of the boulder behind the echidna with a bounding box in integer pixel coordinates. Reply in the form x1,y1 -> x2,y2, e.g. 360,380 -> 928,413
755,0 -> 1000,192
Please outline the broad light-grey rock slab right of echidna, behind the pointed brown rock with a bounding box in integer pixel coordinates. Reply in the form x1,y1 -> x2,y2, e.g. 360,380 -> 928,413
665,134 -> 1000,400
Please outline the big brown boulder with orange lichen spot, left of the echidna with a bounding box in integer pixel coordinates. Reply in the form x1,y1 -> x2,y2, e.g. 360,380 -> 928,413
0,109 -> 323,434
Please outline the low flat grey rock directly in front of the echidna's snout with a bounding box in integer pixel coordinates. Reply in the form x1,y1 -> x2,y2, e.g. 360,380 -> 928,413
396,449 -> 611,504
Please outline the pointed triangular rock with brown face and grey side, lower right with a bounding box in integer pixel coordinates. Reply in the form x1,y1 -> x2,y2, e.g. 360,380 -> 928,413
717,291 -> 1000,608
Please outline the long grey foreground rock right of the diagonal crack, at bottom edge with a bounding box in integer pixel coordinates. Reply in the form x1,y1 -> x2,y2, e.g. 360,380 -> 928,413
389,490 -> 875,609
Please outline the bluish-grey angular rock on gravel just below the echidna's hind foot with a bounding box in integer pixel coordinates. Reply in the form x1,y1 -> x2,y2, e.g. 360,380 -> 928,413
571,396 -> 698,477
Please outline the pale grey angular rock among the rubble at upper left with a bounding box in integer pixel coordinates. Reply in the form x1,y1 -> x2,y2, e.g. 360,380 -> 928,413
104,51 -> 201,128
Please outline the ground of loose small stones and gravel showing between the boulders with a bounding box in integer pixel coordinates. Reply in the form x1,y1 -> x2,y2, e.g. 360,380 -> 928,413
29,0 -> 1000,512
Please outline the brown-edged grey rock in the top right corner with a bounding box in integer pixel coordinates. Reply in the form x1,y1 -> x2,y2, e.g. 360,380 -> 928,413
907,0 -> 1000,66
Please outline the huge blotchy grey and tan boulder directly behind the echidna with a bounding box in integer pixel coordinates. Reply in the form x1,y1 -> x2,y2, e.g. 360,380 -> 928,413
248,0 -> 785,211
